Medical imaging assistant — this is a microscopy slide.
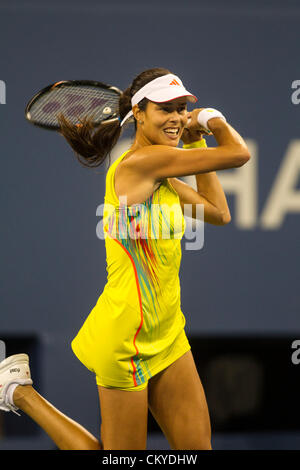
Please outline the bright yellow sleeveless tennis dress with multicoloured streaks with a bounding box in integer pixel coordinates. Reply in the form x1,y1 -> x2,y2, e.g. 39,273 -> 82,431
72,150 -> 191,391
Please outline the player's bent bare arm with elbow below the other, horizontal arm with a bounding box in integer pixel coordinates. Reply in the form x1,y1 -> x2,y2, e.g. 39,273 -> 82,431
168,177 -> 231,225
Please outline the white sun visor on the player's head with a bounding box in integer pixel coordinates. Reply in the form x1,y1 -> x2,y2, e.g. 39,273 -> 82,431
120,73 -> 197,126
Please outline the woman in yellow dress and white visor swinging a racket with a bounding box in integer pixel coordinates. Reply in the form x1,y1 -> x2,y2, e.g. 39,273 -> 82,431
0,68 -> 250,450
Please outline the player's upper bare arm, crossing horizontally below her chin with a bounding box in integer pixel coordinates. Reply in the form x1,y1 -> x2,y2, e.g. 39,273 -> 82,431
126,115 -> 250,181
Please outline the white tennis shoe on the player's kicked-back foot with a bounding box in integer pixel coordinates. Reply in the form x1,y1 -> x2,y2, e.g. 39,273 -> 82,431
0,354 -> 32,416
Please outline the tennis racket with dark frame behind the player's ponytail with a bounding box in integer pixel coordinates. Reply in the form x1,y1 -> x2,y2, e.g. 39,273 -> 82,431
25,80 -> 122,131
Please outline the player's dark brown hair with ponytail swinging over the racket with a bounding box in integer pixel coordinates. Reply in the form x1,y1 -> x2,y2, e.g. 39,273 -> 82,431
58,68 -> 171,168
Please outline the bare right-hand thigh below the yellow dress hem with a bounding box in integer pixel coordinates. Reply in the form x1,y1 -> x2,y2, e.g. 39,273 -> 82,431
148,350 -> 211,449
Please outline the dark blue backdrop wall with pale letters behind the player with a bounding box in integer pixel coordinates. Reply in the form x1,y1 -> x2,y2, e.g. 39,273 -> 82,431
0,0 -> 300,449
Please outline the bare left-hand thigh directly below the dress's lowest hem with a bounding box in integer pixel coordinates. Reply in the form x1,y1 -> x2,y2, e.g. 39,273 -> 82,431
98,385 -> 148,450
